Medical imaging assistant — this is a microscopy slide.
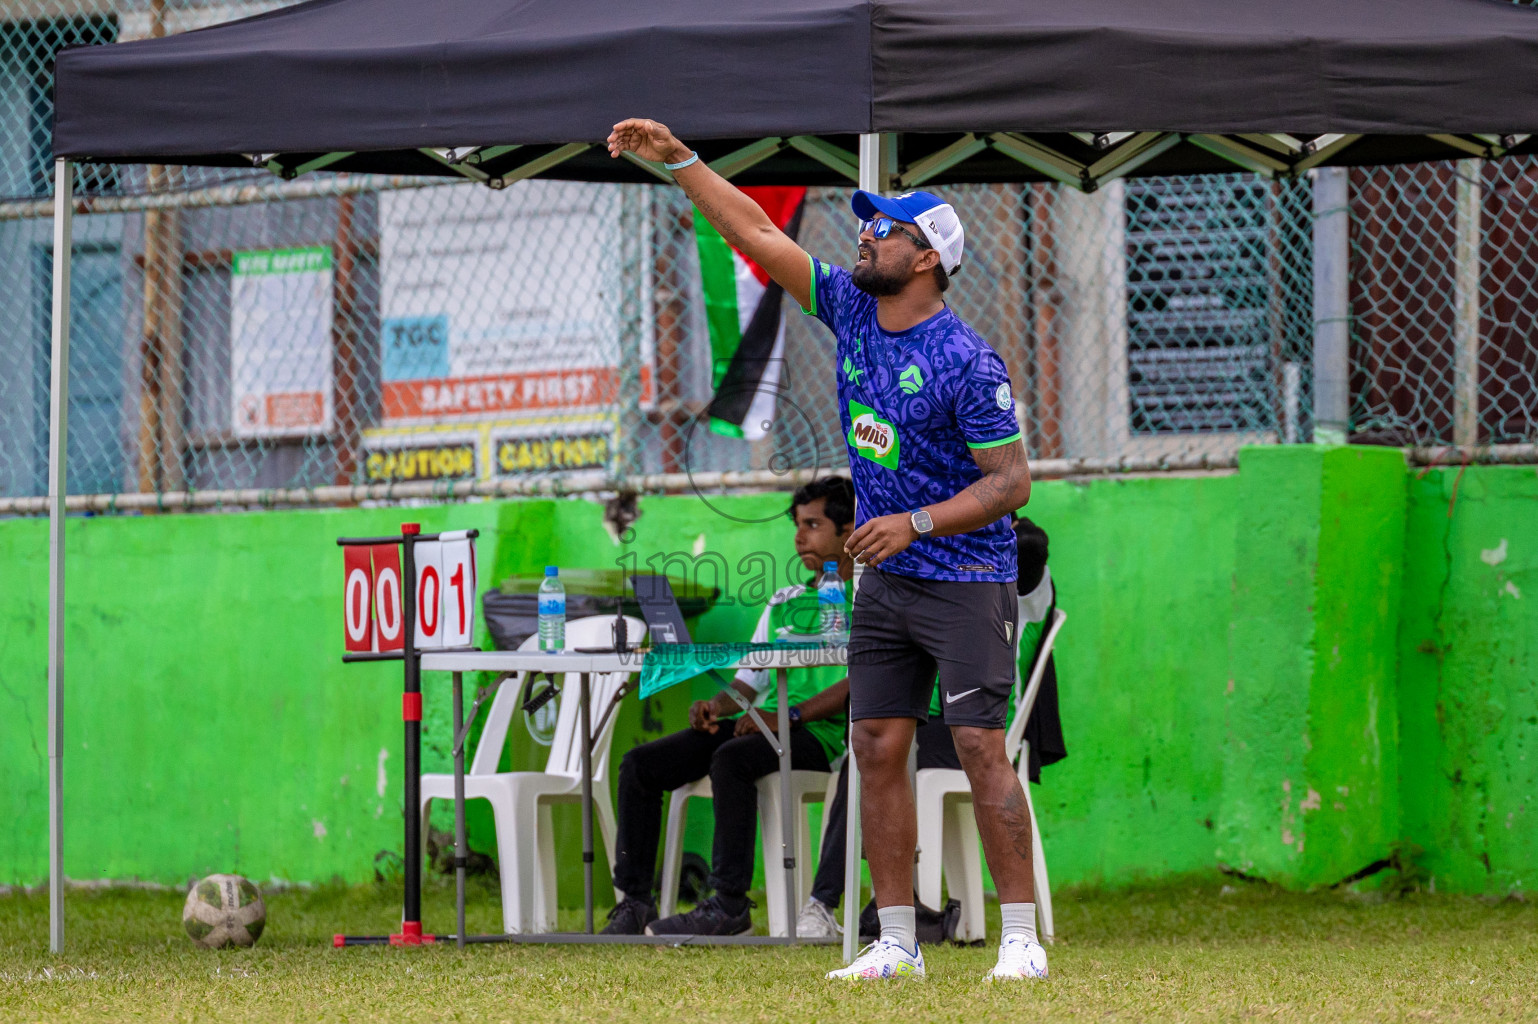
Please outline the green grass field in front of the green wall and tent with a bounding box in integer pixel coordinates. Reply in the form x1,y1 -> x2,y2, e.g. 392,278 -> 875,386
0,883 -> 1538,1024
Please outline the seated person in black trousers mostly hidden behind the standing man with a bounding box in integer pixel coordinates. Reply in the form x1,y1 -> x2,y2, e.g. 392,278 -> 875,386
795,517 -> 1067,939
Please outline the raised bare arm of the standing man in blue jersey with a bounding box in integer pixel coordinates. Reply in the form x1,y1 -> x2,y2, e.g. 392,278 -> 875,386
609,117 -> 812,309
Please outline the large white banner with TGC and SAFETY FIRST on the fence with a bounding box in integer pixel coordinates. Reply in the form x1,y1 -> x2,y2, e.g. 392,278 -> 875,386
380,181 -> 654,424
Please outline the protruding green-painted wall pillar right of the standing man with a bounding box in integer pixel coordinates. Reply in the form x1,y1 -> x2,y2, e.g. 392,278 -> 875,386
1218,447 -> 1404,887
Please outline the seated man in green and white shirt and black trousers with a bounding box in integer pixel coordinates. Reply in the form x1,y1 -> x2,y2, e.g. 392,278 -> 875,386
604,477 -> 855,935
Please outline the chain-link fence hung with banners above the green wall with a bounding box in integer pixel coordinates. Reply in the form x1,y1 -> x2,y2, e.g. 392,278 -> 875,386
0,0 -> 1538,510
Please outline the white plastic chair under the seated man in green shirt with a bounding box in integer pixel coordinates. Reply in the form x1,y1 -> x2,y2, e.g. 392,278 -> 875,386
657,758 -> 843,936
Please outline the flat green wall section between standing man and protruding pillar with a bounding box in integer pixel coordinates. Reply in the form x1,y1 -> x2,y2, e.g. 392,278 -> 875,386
1027,475 -> 1240,884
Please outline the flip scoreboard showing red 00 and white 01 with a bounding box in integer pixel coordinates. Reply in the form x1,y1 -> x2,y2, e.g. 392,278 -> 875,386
341,530 -> 475,653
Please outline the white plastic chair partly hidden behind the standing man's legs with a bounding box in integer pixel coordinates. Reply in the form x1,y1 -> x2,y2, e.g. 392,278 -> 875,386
914,609 -> 1067,943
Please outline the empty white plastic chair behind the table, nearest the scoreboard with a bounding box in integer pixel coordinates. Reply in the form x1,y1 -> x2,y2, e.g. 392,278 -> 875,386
421,615 -> 646,933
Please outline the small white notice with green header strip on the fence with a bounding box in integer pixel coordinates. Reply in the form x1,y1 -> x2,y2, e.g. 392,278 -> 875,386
229,248 -> 332,437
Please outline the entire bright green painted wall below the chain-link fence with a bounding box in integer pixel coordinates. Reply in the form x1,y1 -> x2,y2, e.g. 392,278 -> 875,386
0,447 -> 1538,898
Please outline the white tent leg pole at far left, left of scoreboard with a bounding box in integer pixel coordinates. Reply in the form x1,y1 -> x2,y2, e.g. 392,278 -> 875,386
48,160 -> 74,953
